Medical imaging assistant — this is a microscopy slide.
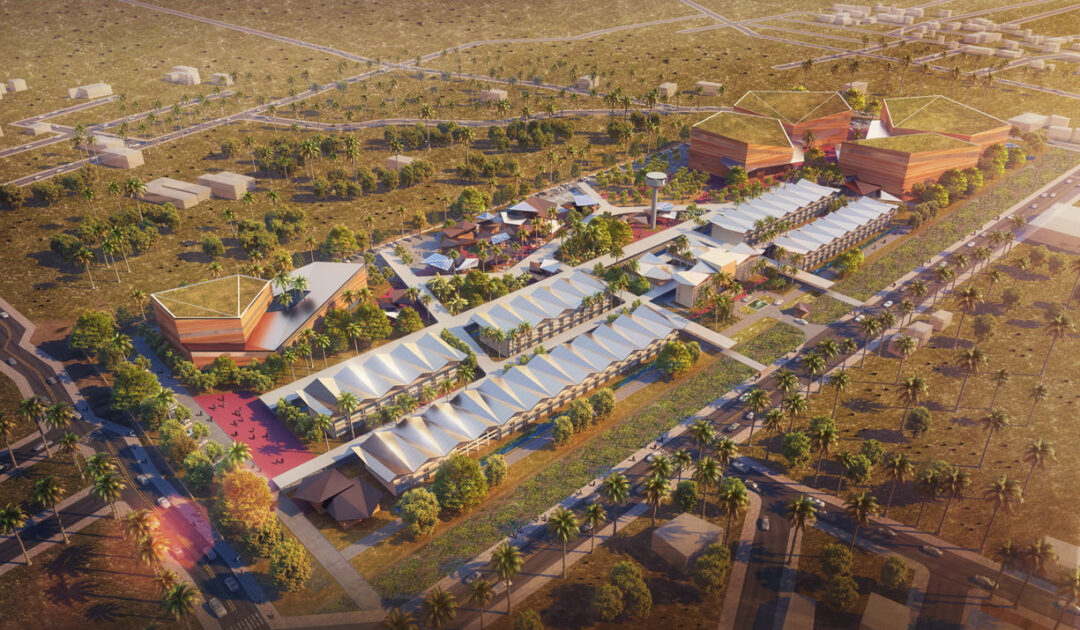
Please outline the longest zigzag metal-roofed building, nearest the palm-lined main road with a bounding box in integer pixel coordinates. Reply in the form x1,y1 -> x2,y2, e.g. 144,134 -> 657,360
352,306 -> 680,495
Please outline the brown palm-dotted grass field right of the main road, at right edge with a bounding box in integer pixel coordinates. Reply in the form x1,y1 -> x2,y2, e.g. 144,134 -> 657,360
754,244 -> 1080,548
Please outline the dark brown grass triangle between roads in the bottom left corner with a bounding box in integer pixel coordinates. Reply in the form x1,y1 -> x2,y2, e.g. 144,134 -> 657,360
0,519 -> 185,630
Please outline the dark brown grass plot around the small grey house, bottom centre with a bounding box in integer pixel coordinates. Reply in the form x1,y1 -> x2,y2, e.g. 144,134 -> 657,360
503,512 -> 743,630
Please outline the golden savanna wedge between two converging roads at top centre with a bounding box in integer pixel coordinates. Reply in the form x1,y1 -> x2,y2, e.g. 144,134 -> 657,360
147,0 -> 696,62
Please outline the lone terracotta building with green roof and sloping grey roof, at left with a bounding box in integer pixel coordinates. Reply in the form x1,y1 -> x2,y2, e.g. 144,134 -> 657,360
150,263 -> 367,367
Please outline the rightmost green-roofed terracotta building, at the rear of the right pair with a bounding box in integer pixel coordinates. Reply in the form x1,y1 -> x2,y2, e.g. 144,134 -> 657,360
881,95 -> 1011,150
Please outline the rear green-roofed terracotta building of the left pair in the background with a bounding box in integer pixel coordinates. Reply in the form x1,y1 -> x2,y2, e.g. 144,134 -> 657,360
734,92 -> 851,146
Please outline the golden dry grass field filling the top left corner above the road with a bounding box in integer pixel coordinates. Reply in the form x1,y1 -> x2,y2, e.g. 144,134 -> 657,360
0,0 -> 345,128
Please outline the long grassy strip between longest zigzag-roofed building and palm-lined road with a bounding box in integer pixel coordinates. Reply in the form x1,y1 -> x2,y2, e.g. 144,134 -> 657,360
352,357 -> 751,599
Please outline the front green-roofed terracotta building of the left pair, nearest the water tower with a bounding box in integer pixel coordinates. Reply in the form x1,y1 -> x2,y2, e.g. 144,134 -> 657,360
689,111 -> 796,177
